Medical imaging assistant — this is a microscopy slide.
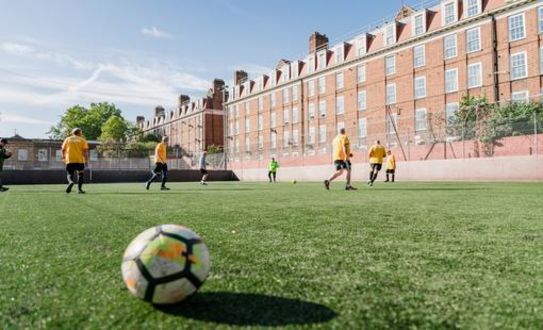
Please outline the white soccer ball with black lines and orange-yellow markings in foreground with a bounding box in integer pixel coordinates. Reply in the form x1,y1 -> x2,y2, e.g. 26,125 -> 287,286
121,225 -> 209,304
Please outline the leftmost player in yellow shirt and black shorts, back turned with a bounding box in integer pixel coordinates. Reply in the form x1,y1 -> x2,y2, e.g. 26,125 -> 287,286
62,128 -> 89,194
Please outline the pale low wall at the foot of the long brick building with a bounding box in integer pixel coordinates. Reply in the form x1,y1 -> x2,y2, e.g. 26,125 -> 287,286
234,156 -> 543,181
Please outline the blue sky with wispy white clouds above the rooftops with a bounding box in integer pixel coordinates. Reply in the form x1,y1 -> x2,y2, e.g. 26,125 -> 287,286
0,0 -> 412,137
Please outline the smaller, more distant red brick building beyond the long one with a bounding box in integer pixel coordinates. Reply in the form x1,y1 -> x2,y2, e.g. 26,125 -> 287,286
136,79 -> 226,156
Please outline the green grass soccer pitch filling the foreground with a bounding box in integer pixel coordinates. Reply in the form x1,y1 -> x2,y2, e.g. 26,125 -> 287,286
0,183 -> 543,329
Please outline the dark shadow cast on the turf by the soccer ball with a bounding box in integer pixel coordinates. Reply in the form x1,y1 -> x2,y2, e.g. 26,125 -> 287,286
157,292 -> 337,326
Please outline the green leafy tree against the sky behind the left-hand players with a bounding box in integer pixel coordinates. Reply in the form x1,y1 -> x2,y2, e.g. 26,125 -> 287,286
48,102 -> 122,140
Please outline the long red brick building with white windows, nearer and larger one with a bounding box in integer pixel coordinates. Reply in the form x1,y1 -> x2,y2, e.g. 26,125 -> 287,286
226,0 -> 543,178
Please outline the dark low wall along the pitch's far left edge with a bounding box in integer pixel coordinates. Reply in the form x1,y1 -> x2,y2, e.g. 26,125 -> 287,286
0,170 -> 238,185
